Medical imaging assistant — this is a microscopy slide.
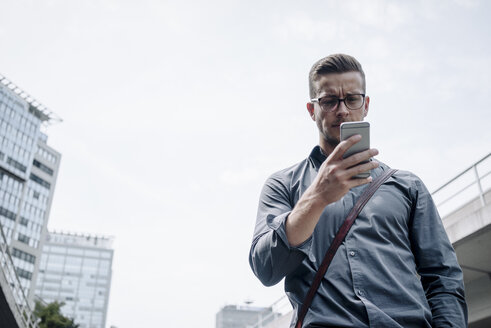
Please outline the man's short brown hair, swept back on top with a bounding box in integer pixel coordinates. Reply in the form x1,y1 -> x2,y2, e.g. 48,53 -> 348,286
309,54 -> 366,99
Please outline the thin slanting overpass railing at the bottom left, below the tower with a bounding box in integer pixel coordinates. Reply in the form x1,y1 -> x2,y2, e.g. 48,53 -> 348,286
0,225 -> 38,328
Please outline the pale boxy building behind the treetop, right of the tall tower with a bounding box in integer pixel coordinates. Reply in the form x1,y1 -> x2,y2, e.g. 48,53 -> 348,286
36,232 -> 113,328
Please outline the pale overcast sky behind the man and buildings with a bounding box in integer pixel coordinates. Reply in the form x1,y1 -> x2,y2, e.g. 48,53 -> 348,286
0,0 -> 491,328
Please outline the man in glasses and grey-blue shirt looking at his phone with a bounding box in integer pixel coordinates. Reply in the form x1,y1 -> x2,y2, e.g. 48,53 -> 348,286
249,54 -> 467,328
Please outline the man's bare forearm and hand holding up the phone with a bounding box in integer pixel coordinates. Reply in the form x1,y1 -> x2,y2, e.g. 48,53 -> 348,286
286,135 -> 378,246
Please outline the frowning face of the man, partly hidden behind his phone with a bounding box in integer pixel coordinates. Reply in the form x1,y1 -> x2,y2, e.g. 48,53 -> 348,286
307,72 -> 370,150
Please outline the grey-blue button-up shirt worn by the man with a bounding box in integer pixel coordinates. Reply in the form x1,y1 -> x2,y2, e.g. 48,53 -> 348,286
249,146 -> 467,328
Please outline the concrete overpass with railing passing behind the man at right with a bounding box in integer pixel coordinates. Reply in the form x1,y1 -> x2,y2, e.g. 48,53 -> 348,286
250,153 -> 491,328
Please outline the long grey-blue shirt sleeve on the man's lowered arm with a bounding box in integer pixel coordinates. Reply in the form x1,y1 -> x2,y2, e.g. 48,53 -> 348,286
410,179 -> 467,327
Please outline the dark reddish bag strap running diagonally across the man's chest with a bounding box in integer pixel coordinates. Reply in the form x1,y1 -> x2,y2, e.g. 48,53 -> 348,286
295,169 -> 397,328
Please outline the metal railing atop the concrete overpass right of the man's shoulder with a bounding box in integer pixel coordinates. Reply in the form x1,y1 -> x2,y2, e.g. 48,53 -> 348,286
431,153 -> 491,217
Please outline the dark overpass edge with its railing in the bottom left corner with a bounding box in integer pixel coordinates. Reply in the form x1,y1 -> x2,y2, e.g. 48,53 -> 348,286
0,226 -> 38,328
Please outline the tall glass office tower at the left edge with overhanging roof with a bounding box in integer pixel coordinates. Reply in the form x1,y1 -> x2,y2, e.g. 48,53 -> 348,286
0,75 -> 61,303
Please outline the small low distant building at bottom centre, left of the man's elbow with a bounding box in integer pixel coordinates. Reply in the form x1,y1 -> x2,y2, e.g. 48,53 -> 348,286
215,305 -> 277,328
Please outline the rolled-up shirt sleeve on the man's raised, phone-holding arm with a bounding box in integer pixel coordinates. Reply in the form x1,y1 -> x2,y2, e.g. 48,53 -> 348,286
249,176 -> 312,286
